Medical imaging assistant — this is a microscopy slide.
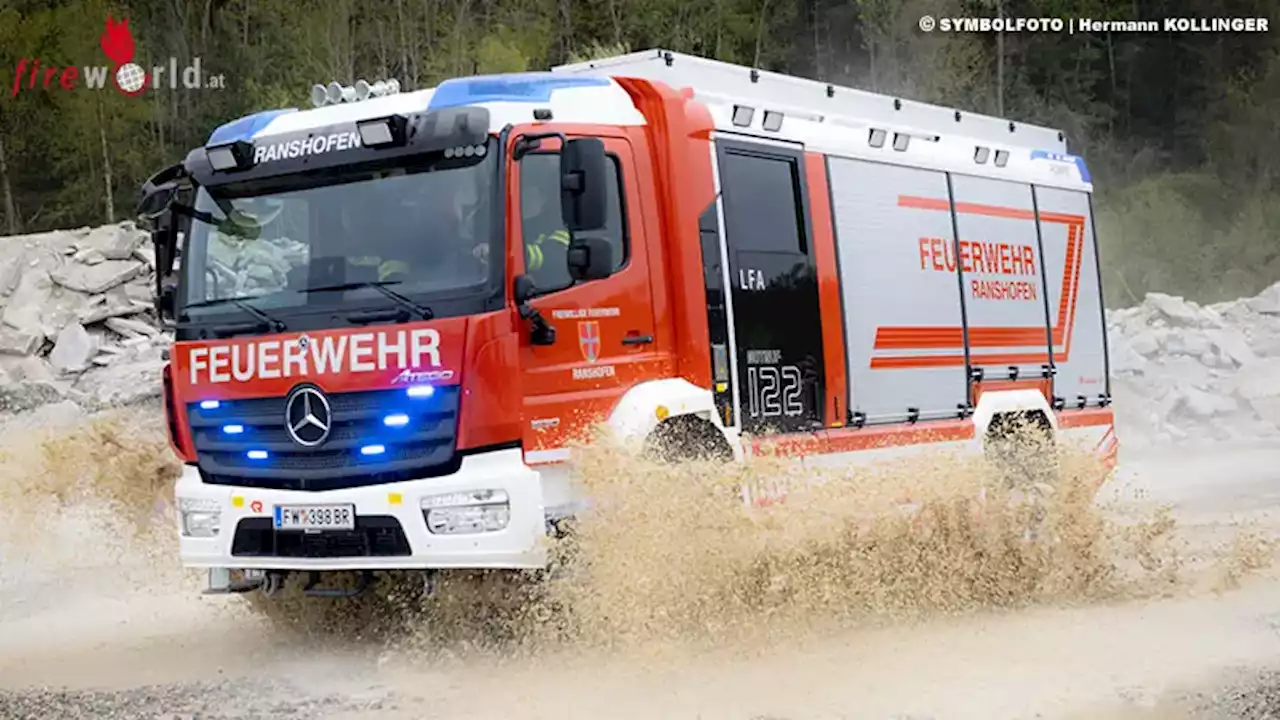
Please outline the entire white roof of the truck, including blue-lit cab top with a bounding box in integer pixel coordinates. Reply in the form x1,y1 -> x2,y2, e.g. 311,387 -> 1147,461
207,50 -> 1092,190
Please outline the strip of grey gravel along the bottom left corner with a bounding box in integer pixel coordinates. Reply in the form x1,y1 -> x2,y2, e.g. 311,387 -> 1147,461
0,680 -> 397,720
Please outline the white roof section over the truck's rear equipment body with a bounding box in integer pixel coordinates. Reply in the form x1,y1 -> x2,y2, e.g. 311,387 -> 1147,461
552,50 -> 1092,190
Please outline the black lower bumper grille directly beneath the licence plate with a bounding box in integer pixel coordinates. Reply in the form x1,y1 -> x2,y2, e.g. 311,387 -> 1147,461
232,515 -> 411,557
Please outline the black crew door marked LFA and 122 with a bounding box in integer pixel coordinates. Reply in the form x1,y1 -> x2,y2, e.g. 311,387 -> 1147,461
717,140 -> 826,434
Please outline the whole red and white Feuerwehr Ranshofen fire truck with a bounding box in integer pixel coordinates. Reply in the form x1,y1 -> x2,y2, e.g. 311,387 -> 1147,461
140,50 -> 1117,592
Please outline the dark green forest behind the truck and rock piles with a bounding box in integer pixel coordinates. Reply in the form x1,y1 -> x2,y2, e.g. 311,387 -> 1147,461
0,0 -> 1280,305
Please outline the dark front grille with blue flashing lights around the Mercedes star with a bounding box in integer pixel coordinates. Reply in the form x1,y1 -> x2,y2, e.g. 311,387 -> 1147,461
187,386 -> 461,491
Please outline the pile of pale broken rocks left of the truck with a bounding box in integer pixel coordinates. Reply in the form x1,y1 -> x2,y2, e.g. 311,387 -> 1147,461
0,222 -> 169,411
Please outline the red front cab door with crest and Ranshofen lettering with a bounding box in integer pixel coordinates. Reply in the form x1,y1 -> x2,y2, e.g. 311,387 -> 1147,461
508,135 -> 655,453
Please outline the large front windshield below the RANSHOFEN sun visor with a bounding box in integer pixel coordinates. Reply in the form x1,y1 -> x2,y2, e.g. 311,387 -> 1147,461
183,141 -> 497,315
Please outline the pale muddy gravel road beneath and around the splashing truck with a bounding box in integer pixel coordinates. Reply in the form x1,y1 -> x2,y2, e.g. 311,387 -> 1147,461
0,430 -> 1280,720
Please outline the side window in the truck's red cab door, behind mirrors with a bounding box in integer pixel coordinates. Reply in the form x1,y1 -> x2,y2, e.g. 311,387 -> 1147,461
520,152 -> 628,293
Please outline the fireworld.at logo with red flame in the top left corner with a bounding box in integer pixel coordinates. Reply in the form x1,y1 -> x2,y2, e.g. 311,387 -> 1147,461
10,15 -> 227,97
